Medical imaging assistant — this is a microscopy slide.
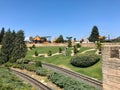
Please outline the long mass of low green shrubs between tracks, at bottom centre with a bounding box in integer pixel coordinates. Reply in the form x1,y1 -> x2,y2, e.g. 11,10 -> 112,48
48,72 -> 96,90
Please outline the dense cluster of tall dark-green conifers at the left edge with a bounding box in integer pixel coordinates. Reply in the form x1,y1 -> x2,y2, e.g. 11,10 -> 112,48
0,29 -> 27,63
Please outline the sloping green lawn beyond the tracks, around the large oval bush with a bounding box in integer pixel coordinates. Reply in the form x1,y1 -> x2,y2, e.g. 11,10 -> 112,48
26,47 -> 102,80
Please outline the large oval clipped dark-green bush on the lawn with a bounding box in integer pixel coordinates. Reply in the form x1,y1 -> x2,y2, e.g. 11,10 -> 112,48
70,54 -> 100,67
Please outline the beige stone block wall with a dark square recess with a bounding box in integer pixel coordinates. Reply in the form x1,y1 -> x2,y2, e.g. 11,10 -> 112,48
102,44 -> 120,90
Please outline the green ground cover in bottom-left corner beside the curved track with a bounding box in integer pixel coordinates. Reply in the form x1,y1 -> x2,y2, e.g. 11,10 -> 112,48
0,67 -> 36,90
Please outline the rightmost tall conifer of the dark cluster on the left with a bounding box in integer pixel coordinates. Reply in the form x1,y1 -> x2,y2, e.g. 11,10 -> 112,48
10,30 -> 27,62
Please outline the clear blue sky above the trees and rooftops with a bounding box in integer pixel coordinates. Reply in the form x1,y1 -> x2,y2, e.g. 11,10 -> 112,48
0,0 -> 120,40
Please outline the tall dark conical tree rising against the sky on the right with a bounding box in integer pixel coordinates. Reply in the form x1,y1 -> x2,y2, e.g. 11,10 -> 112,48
88,26 -> 99,42
